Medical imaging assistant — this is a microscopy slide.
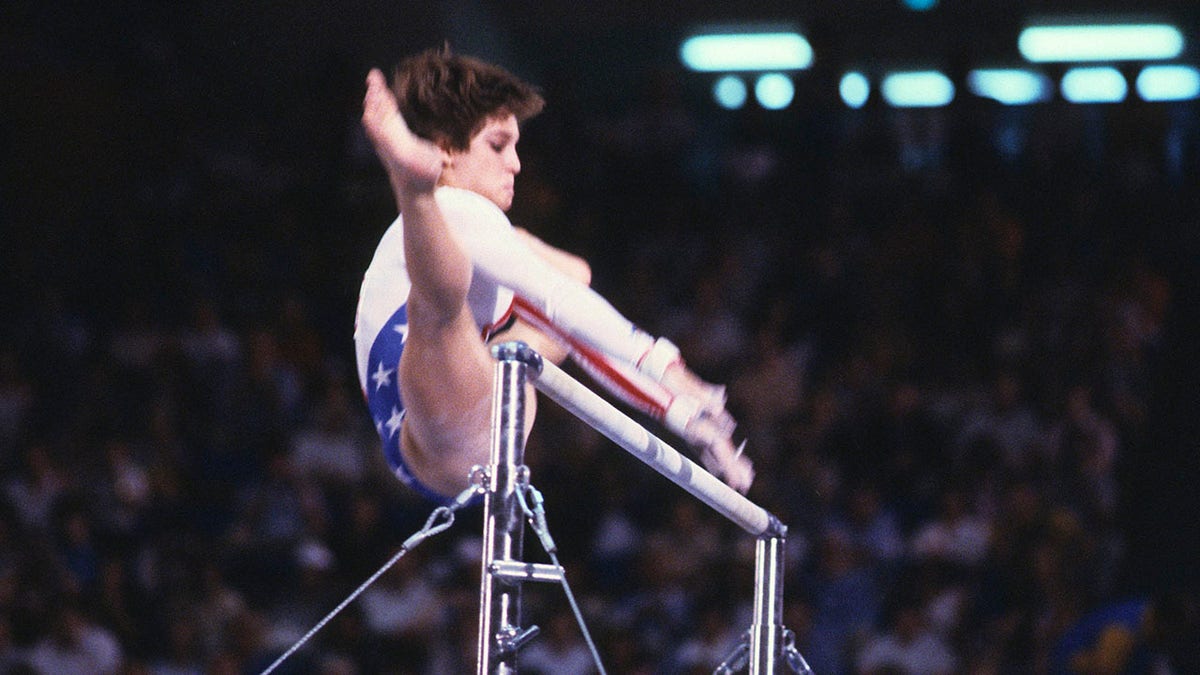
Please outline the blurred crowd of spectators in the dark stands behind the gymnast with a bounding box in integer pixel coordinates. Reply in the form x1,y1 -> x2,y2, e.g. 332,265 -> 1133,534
0,24 -> 1200,675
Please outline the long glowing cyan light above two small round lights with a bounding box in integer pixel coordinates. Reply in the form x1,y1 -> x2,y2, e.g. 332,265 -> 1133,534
679,31 -> 812,72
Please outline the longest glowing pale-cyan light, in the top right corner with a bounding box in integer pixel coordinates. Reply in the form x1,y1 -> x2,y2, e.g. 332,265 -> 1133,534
1016,23 -> 1183,62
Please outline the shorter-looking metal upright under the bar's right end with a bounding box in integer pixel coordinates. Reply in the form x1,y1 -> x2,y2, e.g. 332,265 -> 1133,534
750,537 -> 785,675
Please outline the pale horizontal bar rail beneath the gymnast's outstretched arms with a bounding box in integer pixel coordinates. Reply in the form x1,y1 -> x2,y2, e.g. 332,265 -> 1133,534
494,342 -> 787,537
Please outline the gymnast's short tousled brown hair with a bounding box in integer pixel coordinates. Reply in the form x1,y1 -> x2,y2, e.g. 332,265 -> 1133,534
391,47 -> 546,150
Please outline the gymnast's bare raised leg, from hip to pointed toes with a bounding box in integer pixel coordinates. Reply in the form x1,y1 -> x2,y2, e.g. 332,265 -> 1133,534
362,70 -> 511,495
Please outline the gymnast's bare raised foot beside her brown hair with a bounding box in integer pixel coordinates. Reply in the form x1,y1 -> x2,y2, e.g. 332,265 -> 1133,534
362,68 -> 445,193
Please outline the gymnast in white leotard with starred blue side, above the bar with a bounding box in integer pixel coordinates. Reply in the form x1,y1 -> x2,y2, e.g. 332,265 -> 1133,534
354,48 -> 754,501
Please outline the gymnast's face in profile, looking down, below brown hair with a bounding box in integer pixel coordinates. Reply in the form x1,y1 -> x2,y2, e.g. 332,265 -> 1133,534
442,115 -> 521,211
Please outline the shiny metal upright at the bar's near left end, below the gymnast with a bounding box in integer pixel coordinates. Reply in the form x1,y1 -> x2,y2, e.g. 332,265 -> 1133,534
476,344 -> 530,675
